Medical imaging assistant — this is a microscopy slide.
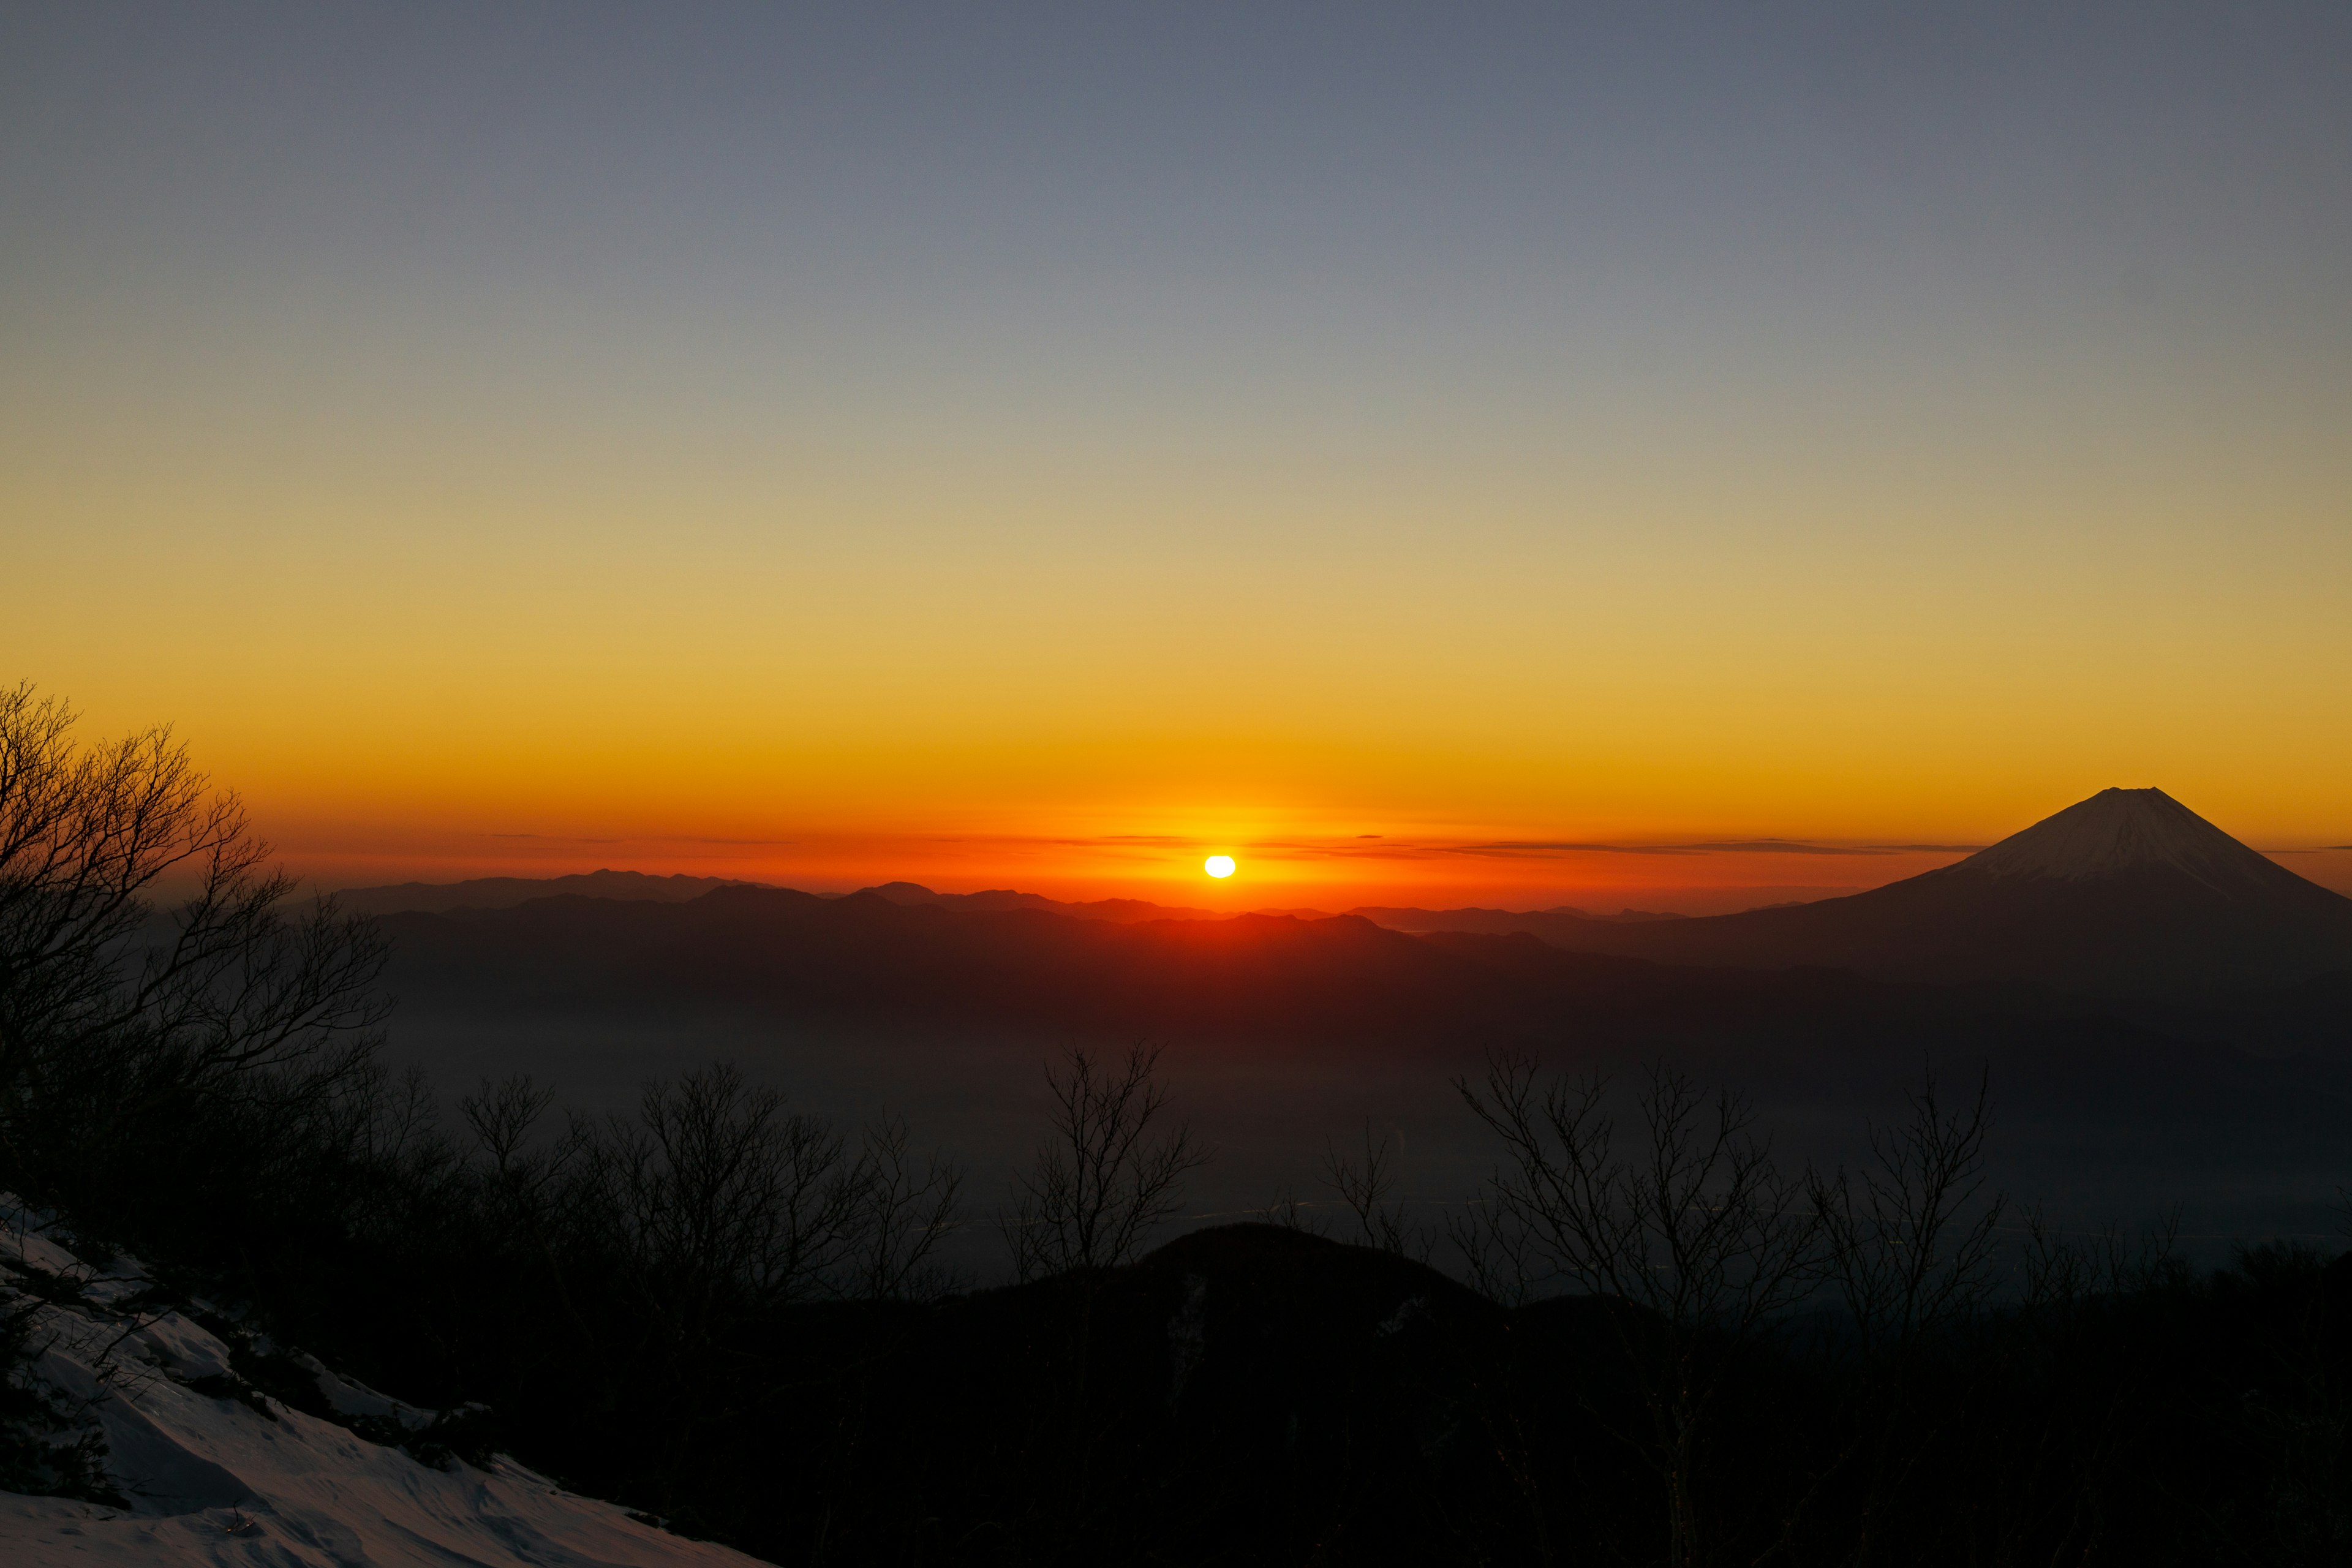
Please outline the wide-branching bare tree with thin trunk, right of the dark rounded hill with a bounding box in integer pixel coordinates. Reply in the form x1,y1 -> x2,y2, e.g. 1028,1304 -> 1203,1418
1456,1055 -> 1820,1566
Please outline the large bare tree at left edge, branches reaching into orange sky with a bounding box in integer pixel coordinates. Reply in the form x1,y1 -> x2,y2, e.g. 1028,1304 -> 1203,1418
0,687 -> 388,1194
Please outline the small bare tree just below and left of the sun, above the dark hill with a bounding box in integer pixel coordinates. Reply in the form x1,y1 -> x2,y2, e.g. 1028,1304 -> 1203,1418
1000,1046 -> 1209,1279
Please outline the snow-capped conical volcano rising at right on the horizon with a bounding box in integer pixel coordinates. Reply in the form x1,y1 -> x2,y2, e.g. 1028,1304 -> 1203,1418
1486,790 -> 2352,997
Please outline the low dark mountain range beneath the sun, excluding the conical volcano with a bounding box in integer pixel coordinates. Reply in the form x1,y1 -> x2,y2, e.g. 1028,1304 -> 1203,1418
383,889 -> 2070,1049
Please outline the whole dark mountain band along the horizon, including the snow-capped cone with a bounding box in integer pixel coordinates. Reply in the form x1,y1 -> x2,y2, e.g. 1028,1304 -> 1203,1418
371,790 -> 2352,1039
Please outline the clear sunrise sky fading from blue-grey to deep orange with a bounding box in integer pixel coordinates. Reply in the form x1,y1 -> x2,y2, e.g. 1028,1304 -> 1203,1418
0,2 -> 2352,910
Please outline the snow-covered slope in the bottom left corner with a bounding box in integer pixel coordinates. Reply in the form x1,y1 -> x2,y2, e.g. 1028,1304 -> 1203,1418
0,1199 -> 755,1568
